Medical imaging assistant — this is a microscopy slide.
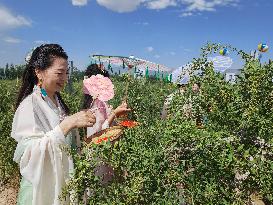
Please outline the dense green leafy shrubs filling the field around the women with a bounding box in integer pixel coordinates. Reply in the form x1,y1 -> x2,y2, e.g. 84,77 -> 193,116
0,44 -> 273,204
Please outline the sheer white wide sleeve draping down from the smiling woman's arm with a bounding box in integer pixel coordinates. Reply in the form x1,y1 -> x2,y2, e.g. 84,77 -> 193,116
11,98 -> 69,204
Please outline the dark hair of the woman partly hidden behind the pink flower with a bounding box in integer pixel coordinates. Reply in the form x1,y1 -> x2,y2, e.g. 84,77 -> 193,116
82,64 -> 110,109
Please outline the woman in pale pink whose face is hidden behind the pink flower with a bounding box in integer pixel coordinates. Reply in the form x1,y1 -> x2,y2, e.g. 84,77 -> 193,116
83,64 -> 131,137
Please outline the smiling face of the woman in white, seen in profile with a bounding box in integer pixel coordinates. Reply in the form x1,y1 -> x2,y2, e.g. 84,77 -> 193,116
37,57 -> 68,94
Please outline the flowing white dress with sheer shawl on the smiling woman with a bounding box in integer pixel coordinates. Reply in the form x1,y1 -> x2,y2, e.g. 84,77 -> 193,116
11,86 -> 78,205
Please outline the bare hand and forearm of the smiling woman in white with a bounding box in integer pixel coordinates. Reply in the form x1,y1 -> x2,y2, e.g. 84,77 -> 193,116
60,110 -> 96,135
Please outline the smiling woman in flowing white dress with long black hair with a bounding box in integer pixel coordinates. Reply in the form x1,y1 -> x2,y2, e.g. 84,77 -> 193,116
11,44 -> 95,205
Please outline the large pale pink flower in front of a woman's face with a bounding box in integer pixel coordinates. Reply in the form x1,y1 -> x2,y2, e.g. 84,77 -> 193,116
83,74 -> 114,102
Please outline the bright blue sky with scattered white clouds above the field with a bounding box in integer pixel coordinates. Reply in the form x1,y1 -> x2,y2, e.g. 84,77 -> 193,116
0,0 -> 273,69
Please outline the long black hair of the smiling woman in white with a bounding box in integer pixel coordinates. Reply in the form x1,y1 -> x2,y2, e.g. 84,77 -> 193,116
16,44 -> 69,114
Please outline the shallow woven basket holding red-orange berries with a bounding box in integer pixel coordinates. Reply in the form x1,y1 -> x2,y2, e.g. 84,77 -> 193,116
85,126 -> 123,144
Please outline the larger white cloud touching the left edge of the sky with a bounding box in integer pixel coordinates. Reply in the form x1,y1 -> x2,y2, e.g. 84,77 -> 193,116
0,6 -> 31,30
